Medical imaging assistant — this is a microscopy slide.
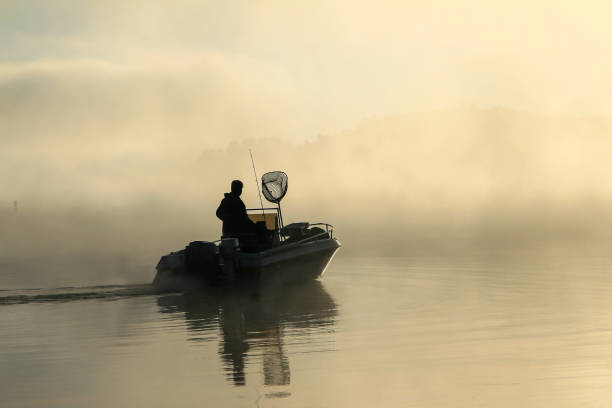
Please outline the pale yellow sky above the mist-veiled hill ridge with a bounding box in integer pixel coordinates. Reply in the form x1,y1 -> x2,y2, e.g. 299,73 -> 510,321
0,0 -> 612,140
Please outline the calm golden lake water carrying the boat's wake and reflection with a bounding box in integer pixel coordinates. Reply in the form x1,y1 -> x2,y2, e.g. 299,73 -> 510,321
0,252 -> 612,407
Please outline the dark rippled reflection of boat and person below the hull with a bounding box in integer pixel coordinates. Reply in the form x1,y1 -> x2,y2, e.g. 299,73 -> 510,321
157,281 -> 337,385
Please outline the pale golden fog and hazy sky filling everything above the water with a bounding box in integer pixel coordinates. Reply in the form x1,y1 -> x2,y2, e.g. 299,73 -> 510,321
0,0 -> 612,284
